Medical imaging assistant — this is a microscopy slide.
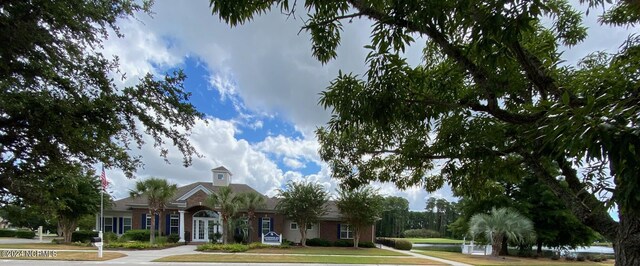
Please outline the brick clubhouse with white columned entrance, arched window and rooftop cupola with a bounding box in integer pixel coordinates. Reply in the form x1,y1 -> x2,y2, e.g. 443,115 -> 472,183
96,166 -> 375,243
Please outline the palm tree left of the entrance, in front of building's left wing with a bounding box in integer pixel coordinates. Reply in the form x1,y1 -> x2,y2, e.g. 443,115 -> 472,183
129,177 -> 178,244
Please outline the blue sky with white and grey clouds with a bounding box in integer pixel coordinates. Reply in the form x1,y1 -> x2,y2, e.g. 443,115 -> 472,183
104,0 -> 627,210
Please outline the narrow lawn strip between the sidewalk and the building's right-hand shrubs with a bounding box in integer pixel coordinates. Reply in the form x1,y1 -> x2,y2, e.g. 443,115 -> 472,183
246,247 -> 406,256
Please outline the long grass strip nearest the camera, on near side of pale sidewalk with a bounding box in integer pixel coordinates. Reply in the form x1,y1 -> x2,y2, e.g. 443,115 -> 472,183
154,254 -> 444,265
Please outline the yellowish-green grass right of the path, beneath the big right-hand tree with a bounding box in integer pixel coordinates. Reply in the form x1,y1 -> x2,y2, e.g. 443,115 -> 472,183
414,250 -> 614,266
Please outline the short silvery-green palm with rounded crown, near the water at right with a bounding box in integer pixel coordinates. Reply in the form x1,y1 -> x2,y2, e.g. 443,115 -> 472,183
469,208 -> 535,256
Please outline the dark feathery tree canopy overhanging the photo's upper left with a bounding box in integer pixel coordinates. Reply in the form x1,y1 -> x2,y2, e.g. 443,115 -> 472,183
0,0 -> 202,204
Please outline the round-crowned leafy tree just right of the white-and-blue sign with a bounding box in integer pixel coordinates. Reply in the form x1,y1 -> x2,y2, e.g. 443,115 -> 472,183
276,181 -> 329,247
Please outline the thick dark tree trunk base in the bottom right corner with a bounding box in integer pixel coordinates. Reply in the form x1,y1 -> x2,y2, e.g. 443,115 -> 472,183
613,211 -> 640,266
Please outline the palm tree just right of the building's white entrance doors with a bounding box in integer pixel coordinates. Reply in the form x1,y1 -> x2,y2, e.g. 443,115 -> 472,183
206,187 -> 242,244
